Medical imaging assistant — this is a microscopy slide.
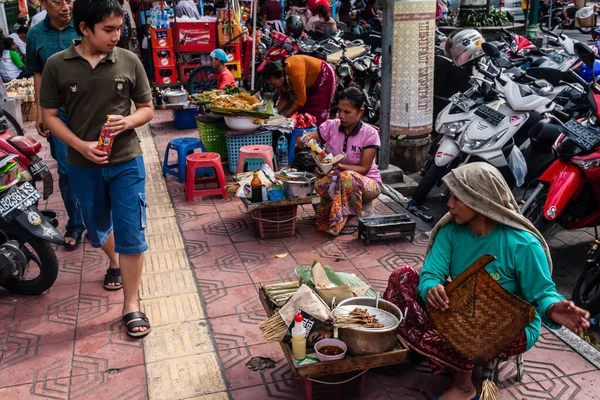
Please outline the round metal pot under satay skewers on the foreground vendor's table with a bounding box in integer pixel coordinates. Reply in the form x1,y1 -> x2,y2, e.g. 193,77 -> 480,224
338,297 -> 404,356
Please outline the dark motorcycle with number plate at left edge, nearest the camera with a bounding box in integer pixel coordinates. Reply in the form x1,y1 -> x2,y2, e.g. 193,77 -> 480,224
0,152 -> 64,295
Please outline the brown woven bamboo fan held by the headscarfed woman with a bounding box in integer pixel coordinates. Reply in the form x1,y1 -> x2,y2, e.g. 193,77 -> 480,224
427,255 -> 535,362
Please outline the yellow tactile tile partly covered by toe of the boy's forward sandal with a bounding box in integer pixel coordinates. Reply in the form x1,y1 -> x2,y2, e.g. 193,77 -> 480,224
144,320 -> 215,363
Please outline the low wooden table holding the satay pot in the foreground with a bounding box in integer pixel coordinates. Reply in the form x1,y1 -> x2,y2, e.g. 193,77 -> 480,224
259,290 -> 408,400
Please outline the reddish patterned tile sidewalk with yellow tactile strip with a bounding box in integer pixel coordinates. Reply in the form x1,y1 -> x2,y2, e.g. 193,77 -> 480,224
0,111 -> 600,400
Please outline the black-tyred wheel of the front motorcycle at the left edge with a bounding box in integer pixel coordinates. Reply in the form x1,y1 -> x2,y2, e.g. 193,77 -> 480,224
0,227 -> 58,295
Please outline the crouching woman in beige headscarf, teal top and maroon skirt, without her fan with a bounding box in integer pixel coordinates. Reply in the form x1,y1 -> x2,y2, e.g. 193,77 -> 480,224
384,163 -> 590,400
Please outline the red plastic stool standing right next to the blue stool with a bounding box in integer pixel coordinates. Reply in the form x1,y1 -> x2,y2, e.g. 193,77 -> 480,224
185,153 -> 228,202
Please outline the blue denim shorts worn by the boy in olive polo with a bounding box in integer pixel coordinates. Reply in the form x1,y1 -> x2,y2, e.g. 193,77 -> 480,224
69,156 -> 148,254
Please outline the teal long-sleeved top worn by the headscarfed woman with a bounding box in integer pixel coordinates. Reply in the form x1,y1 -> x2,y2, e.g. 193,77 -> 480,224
419,222 -> 564,350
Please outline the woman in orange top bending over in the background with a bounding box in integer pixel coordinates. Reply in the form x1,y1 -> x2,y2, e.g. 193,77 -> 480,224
262,55 -> 335,125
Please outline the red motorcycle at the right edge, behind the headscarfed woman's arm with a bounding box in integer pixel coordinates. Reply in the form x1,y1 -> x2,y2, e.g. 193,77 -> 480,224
521,44 -> 600,315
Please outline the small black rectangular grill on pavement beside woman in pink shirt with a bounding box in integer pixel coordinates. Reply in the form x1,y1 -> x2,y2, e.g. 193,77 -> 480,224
358,214 -> 417,246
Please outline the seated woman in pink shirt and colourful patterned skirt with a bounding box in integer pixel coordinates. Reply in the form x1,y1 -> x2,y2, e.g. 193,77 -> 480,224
297,88 -> 382,235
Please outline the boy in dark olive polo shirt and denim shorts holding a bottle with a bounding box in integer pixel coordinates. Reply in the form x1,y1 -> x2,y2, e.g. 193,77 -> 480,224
40,0 -> 154,337
